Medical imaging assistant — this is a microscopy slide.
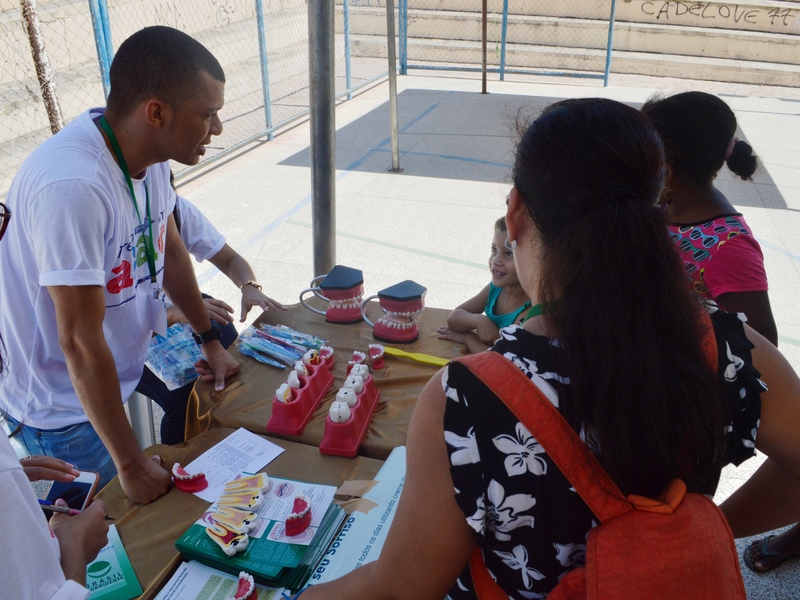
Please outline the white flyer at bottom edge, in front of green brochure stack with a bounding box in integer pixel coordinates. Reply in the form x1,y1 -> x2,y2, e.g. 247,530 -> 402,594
155,561 -> 283,600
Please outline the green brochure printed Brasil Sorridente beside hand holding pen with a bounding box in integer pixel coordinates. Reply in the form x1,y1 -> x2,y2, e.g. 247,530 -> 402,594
86,525 -> 142,600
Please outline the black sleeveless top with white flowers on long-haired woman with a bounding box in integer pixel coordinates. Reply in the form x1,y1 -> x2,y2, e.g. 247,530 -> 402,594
442,311 -> 766,600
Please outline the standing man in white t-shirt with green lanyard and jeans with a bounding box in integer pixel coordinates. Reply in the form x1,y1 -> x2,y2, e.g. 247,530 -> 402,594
0,27 -> 239,503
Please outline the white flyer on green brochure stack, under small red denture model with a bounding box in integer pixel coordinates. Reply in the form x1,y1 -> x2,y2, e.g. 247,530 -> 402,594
197,477 -> 336,546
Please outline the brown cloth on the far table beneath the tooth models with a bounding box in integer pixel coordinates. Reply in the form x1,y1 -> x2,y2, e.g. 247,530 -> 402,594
186,298 -> 466,460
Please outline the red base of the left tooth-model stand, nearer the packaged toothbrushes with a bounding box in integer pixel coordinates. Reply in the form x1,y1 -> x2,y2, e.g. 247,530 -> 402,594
267,359 -> 333,435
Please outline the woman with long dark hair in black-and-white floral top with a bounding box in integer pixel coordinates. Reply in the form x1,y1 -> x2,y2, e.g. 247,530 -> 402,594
302,99 -> 800,600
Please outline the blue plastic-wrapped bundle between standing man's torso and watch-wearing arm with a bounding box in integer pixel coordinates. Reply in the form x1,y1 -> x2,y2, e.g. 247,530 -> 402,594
145,323 -> 203,391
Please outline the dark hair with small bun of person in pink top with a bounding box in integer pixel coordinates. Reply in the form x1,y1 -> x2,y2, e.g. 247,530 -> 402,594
642,92 -> 757,186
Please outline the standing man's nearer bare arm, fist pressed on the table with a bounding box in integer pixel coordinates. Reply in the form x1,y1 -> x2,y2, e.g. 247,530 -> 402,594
48,286 -> 170,504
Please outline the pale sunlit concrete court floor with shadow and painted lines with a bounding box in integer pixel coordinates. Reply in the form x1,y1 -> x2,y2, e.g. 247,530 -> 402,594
172,76 -> 800,600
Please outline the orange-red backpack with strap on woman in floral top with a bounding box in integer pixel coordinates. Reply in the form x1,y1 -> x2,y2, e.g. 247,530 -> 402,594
459,323 -> 746,600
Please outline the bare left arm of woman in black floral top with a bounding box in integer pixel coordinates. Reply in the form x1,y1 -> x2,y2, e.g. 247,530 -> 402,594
300,371 -> 476,600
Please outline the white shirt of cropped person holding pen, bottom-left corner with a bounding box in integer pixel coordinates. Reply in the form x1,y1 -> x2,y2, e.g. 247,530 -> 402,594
0,428 -> 89,600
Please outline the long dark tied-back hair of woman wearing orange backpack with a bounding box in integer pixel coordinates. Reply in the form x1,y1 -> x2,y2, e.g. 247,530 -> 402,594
514,99 -> 723,496
